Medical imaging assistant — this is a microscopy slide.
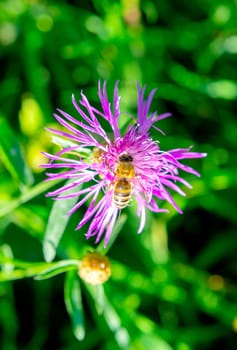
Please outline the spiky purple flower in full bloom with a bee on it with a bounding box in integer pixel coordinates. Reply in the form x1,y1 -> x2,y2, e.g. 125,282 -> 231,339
42,83 -> 206,246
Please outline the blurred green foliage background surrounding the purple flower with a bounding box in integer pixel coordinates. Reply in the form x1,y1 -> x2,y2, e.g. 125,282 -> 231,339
0,0 -> 237,350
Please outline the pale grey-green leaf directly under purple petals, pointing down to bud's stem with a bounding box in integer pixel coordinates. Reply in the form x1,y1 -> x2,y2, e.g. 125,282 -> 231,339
43,180 -> 79,262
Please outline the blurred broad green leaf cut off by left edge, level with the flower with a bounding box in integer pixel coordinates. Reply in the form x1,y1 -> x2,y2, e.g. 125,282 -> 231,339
0,118 -> 33,186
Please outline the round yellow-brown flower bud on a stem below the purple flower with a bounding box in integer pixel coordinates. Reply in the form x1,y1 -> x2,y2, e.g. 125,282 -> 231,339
78,252 -> 111,285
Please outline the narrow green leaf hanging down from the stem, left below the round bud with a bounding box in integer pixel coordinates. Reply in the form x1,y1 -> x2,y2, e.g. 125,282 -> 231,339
64,271 -> 85,340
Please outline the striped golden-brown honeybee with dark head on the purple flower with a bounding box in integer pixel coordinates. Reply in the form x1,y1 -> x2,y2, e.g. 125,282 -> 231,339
112,153 -> 135,209
